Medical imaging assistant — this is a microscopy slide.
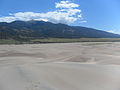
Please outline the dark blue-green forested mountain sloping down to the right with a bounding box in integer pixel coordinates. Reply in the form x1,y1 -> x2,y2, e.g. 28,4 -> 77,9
0,21 -> 120,39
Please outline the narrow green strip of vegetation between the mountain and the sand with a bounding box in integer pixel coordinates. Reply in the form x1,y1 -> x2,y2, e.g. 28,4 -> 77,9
0,38 -> 120,44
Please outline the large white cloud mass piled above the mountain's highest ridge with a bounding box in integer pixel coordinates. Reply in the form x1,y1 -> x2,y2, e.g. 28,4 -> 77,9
0,1 -> 84,24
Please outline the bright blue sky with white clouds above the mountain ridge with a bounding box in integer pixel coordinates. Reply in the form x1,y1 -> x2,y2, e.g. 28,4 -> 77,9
0,0 -> 120,34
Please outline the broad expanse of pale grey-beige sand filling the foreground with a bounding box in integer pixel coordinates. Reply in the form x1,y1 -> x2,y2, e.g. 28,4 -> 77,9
0,42 -> 120,90
